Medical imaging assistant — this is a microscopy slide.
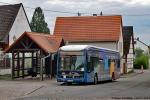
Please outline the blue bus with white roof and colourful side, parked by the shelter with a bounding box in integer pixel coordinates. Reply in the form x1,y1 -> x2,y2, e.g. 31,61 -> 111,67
57,45 -> 120,84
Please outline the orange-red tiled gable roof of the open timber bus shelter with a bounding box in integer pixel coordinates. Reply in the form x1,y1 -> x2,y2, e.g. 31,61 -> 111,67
6,32 -> 62,53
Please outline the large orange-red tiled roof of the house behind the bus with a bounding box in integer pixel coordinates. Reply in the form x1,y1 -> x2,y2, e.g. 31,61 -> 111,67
54,15 -> 122,42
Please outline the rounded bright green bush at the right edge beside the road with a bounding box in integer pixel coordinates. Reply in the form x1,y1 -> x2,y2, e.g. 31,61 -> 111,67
134,54 -> 149,69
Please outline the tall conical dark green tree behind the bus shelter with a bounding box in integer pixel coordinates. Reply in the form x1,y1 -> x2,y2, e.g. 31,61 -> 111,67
30,7 -> 50,33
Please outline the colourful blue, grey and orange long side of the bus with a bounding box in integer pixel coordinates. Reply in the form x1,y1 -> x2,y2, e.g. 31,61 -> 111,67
85,50 -> 119,83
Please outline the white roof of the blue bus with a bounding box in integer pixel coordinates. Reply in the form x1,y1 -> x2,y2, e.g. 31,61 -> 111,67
59,45 -> 119,52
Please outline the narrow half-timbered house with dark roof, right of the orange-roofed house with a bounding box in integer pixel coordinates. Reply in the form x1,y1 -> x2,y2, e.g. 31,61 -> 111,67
123,26 -> 135,73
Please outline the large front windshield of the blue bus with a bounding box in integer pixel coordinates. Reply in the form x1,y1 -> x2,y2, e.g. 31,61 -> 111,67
60,52 -> 84,71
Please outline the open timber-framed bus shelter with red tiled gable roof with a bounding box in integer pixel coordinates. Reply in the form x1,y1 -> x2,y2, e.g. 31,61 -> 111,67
5,32 -> 65,78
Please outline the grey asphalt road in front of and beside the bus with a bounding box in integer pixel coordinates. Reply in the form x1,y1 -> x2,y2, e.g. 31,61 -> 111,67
14,70 -> 150,100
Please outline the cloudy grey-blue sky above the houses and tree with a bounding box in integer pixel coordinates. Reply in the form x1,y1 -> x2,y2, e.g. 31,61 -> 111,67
0,0 -> 150,48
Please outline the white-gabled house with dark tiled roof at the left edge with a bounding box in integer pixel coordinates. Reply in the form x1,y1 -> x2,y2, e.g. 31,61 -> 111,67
0,3 -> 31,67
